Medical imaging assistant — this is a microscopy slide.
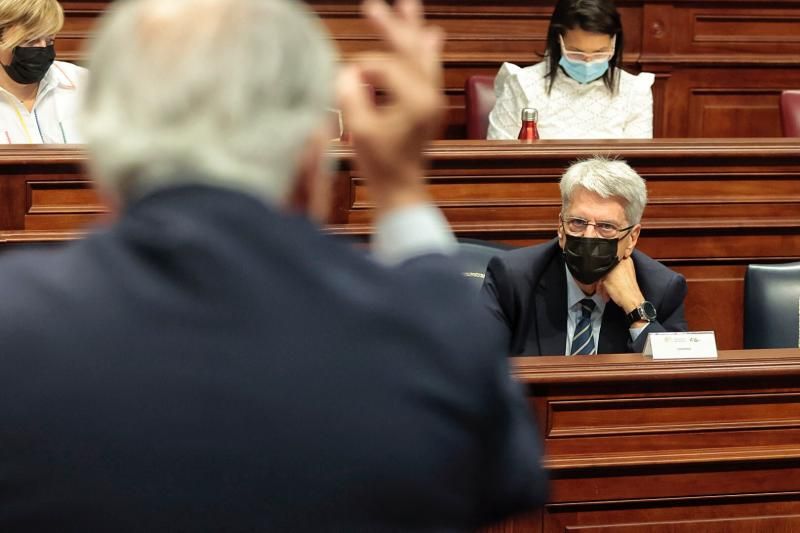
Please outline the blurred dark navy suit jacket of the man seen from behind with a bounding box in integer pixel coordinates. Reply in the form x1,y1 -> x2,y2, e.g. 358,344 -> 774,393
0,187 -> 544,532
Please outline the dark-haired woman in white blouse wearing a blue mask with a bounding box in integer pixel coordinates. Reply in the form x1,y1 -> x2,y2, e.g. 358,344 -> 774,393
487,0 -> 655,139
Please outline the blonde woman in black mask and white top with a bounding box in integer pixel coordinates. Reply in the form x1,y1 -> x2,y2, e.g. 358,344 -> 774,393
0,0 -> 87,144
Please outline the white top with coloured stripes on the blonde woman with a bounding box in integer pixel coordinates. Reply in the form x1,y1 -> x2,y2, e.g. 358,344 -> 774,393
0,61 -> 88,144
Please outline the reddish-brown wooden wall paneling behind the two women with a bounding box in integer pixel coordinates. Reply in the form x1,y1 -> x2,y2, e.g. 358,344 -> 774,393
57,0 -> 800,139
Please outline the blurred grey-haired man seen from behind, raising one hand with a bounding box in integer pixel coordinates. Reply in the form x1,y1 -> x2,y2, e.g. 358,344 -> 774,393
0,0 -> 544,533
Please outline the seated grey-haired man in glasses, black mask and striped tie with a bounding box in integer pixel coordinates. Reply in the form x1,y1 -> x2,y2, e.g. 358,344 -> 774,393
481,157 -> 687,355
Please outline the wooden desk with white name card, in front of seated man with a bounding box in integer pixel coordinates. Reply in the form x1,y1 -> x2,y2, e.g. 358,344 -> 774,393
491,350 -> 800,533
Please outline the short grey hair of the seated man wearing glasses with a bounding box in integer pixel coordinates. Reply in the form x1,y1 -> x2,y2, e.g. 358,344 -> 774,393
559,156 -> 647,224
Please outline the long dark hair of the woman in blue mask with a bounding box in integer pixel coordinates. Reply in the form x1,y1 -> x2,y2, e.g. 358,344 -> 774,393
545,0 -> 625,94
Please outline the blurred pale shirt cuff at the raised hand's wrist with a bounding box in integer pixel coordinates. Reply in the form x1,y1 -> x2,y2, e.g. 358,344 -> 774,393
372,204 -> 458,265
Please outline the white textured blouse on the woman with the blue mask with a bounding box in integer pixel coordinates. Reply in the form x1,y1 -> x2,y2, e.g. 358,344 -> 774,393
487,61 -> 655,139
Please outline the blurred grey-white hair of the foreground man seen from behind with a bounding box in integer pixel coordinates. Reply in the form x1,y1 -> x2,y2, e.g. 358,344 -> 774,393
80,0 -> 336,204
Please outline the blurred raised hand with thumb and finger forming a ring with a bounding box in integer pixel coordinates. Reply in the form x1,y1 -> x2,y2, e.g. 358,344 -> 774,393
338,0 -> 444,212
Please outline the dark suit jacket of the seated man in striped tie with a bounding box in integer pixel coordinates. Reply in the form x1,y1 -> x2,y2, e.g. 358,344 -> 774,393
481,240 -> 687,355
